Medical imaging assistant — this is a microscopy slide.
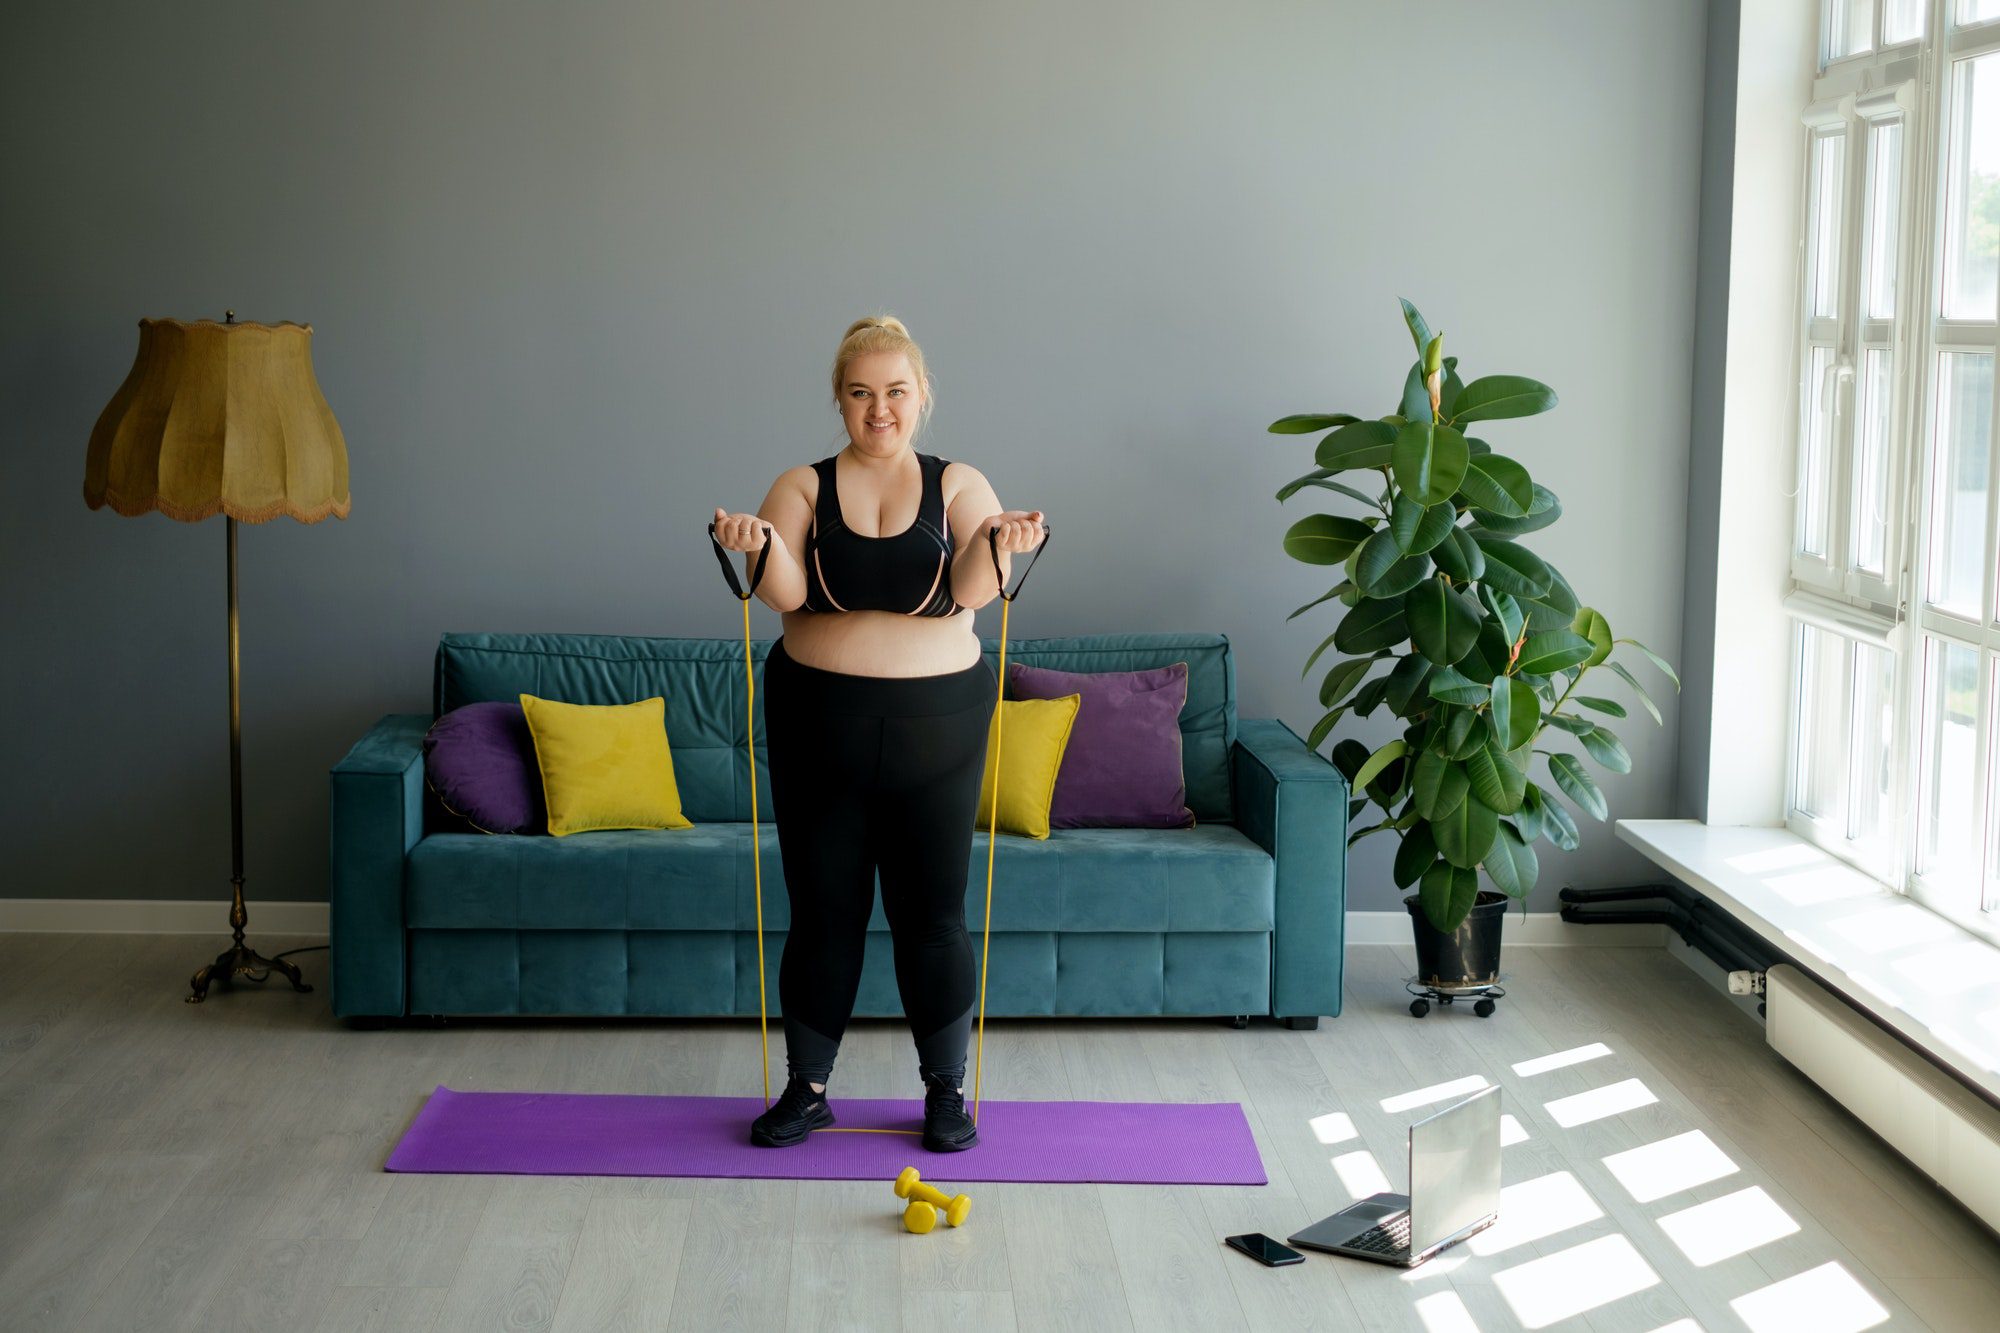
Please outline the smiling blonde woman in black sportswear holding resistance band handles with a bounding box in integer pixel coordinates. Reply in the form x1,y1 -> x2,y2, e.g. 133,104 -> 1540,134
714,316 -> 1042,1153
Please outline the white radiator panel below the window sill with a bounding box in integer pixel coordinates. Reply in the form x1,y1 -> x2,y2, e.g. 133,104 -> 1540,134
1764,963 -> 2000,1231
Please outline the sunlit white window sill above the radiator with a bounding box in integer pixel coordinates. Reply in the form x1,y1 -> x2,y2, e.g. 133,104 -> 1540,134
1616,819 -> 2000,1105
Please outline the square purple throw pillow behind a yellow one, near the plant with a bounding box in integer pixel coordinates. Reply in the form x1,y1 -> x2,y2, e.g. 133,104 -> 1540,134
1006,662 -> 1194,829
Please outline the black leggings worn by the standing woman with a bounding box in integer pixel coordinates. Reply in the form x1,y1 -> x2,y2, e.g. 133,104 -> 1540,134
762,636 -> 1000,1087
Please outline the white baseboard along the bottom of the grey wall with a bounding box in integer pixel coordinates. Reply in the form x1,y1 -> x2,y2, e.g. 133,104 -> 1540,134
0,899 -> 1668,947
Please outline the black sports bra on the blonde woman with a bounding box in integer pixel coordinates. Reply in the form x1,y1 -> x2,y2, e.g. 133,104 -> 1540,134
806,454 -> 962,616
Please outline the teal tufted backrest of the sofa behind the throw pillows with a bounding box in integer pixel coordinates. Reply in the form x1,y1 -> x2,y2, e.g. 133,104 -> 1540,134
430,632 -> 1236,825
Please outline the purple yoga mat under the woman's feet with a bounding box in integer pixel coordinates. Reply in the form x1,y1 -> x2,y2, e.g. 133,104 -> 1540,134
384,1085 -> 1266,1185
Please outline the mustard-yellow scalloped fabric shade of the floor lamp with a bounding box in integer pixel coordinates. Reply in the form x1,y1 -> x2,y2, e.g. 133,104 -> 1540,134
84,320 -> 350,522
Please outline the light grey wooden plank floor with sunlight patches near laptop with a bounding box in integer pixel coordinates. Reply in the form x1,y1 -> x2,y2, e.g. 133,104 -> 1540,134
0,935 -> 2000,1333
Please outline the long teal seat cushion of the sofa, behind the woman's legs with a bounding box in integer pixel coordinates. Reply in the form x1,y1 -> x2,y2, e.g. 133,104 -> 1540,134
404,823 -> 1276,939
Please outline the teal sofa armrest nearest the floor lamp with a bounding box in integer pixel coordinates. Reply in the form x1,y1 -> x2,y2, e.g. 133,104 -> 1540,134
326,713 -> 432,1017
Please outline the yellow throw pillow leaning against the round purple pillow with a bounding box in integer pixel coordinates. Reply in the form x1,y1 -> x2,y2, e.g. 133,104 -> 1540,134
520,695 -> 694,839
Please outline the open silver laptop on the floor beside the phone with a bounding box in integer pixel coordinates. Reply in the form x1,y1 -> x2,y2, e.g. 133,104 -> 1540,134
1288,1085 -> 1500,1267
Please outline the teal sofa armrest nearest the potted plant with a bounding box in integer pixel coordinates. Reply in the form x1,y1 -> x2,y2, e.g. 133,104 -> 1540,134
1230,719 -> 1348,1019
